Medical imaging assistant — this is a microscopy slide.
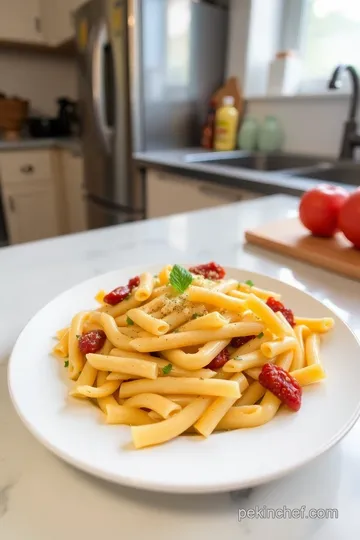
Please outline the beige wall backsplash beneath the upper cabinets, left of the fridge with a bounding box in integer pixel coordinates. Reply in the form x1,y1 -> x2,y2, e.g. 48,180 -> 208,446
0,49 -> 77,115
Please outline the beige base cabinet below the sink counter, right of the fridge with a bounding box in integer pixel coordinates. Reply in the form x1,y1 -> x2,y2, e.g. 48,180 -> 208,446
146,169 -> 260,218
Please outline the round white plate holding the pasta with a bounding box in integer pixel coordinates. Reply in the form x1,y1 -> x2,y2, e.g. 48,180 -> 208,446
8,267 -> 360,493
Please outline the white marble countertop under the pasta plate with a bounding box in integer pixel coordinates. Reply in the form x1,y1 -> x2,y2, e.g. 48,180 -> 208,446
0,196 -> 360,540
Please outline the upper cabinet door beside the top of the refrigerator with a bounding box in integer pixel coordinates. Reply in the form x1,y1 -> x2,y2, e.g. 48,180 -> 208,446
40,0 -> 85,46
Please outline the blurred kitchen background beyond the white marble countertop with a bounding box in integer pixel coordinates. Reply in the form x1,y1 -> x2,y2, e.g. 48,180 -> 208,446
0,0 -> 360,246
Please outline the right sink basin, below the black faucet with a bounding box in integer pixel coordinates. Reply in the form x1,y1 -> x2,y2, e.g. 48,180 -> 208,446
290,162 -> 360,186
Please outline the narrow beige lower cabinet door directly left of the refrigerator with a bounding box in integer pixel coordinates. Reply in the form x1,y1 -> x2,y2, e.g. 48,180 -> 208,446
63,151 -> 88,232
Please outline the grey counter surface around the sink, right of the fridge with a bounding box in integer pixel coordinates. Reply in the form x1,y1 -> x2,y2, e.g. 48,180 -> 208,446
133,148 -> 354,197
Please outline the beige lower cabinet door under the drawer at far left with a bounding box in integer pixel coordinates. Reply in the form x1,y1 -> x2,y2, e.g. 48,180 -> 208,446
2,180 -> 59,244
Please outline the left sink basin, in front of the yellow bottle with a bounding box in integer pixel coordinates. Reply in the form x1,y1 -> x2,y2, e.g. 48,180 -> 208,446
185,152 -> 324,171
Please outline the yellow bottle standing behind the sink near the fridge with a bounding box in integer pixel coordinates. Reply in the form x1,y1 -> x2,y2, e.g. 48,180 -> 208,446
214,96 -> 239,150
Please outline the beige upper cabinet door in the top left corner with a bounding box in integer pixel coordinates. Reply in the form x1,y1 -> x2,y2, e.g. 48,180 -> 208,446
0,0 -> 44,43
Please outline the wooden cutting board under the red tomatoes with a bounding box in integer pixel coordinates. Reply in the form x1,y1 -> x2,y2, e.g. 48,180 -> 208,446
245,218 -> 360,279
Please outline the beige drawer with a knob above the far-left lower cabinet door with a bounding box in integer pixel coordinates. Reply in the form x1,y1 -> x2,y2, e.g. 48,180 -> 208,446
0,150 -> 52,184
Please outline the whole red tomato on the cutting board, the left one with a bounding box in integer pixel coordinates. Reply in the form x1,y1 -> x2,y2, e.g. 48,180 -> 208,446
299,184 -> 349,236
